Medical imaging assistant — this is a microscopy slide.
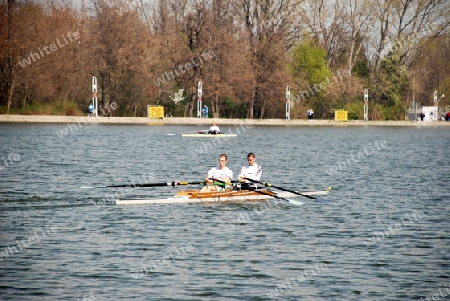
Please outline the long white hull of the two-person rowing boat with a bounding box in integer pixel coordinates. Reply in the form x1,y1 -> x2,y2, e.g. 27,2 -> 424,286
116,190 -> 328,205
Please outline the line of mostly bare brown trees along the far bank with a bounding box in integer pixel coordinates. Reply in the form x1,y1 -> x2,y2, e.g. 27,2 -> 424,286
0,0 -> 450,120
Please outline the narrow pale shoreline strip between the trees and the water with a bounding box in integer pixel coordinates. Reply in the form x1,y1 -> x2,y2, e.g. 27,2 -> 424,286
0,115 -> 450,128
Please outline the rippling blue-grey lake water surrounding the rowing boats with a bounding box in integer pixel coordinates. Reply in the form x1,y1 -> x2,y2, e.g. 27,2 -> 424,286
0,124 -> 450,301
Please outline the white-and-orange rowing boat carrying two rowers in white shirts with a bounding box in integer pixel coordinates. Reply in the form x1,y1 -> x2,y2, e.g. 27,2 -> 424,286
116,189 -> 329,205
